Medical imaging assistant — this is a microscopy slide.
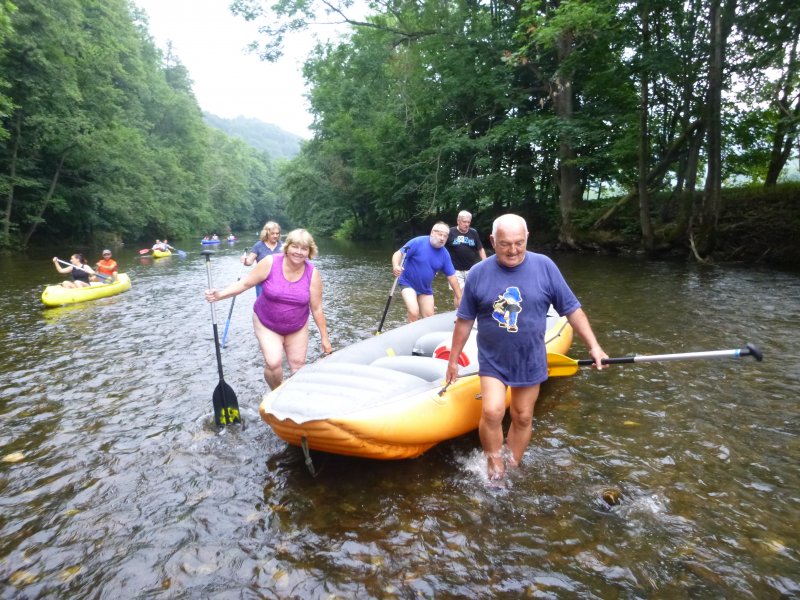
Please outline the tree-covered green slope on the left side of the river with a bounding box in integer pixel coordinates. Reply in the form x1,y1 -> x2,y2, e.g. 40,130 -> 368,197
0,0 -> 283,248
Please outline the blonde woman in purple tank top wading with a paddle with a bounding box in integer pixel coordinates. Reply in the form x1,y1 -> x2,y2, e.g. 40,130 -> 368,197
206,229 -> 331,390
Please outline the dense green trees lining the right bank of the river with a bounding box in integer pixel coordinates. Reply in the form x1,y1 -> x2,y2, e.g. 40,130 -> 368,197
233,0 -> 800,257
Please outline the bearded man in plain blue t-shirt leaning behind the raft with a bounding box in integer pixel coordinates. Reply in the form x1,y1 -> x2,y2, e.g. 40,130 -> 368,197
392,221 -> 461,323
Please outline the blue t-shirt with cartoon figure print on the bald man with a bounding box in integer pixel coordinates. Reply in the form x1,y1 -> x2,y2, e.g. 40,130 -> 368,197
457,252 -> 581,387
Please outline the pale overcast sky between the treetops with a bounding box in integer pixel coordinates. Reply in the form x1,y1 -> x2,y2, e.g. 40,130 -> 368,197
134,0 -> 344,139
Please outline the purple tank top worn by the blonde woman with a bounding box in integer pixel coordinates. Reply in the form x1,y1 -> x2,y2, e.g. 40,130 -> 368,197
253,252 -> 314,335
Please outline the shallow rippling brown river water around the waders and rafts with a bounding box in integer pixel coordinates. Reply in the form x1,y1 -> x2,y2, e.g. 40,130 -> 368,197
0,242 -> 800,600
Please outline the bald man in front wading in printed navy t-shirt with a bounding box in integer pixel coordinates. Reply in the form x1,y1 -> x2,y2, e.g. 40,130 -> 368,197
447,214 -> 608,480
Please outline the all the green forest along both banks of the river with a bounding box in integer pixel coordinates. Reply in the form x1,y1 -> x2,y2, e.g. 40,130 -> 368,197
0,0 -> 800,259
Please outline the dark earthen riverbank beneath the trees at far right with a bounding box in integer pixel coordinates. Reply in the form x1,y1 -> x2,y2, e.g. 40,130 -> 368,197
575,183 -> 800,265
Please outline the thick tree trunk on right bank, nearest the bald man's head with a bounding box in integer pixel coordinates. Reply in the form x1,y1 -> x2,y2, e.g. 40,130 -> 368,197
552,32 -> 581,248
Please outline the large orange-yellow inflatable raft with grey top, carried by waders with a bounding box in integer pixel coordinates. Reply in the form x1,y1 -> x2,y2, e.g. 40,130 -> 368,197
259,309 -> 572,460
